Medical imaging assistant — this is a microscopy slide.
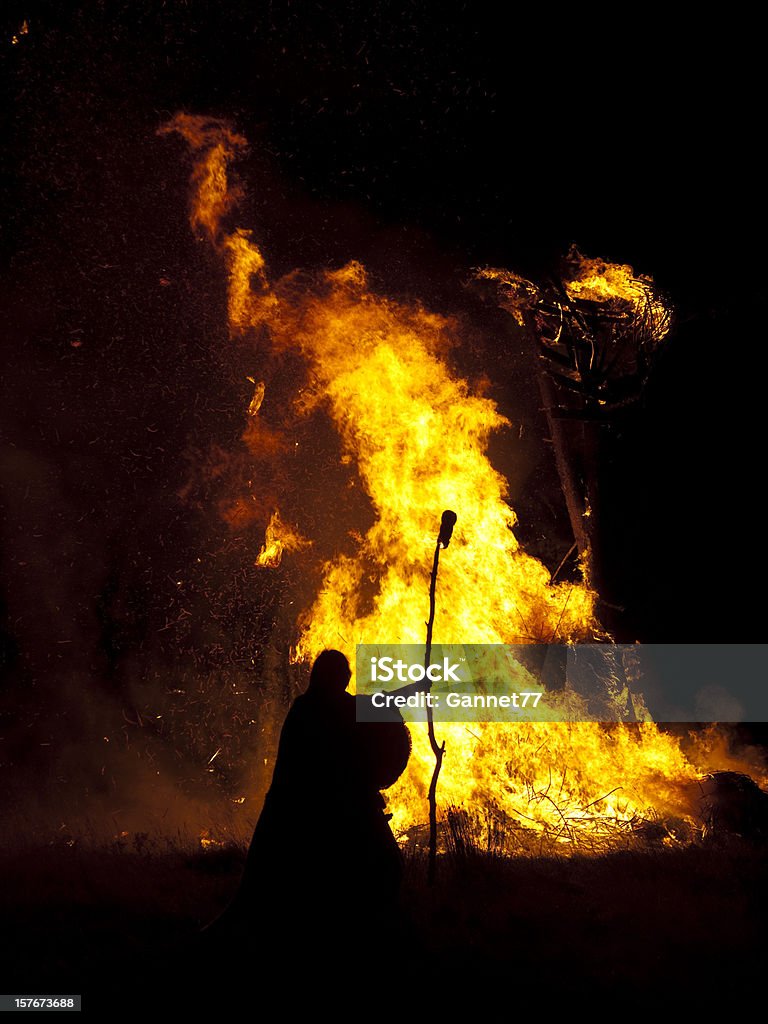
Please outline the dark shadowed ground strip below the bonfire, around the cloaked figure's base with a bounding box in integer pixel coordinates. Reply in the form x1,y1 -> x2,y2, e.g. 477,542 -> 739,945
2,839 -> 768,1014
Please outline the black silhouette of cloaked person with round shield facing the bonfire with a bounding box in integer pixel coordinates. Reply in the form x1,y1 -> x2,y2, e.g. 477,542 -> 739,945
219,650 -> 411,956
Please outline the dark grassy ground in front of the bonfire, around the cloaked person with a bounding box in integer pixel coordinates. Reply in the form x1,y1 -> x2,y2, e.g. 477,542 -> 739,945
0,838 -> 768,1000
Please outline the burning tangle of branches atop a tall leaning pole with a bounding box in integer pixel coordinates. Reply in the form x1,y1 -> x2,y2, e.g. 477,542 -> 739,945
478,253 -> 673,629
